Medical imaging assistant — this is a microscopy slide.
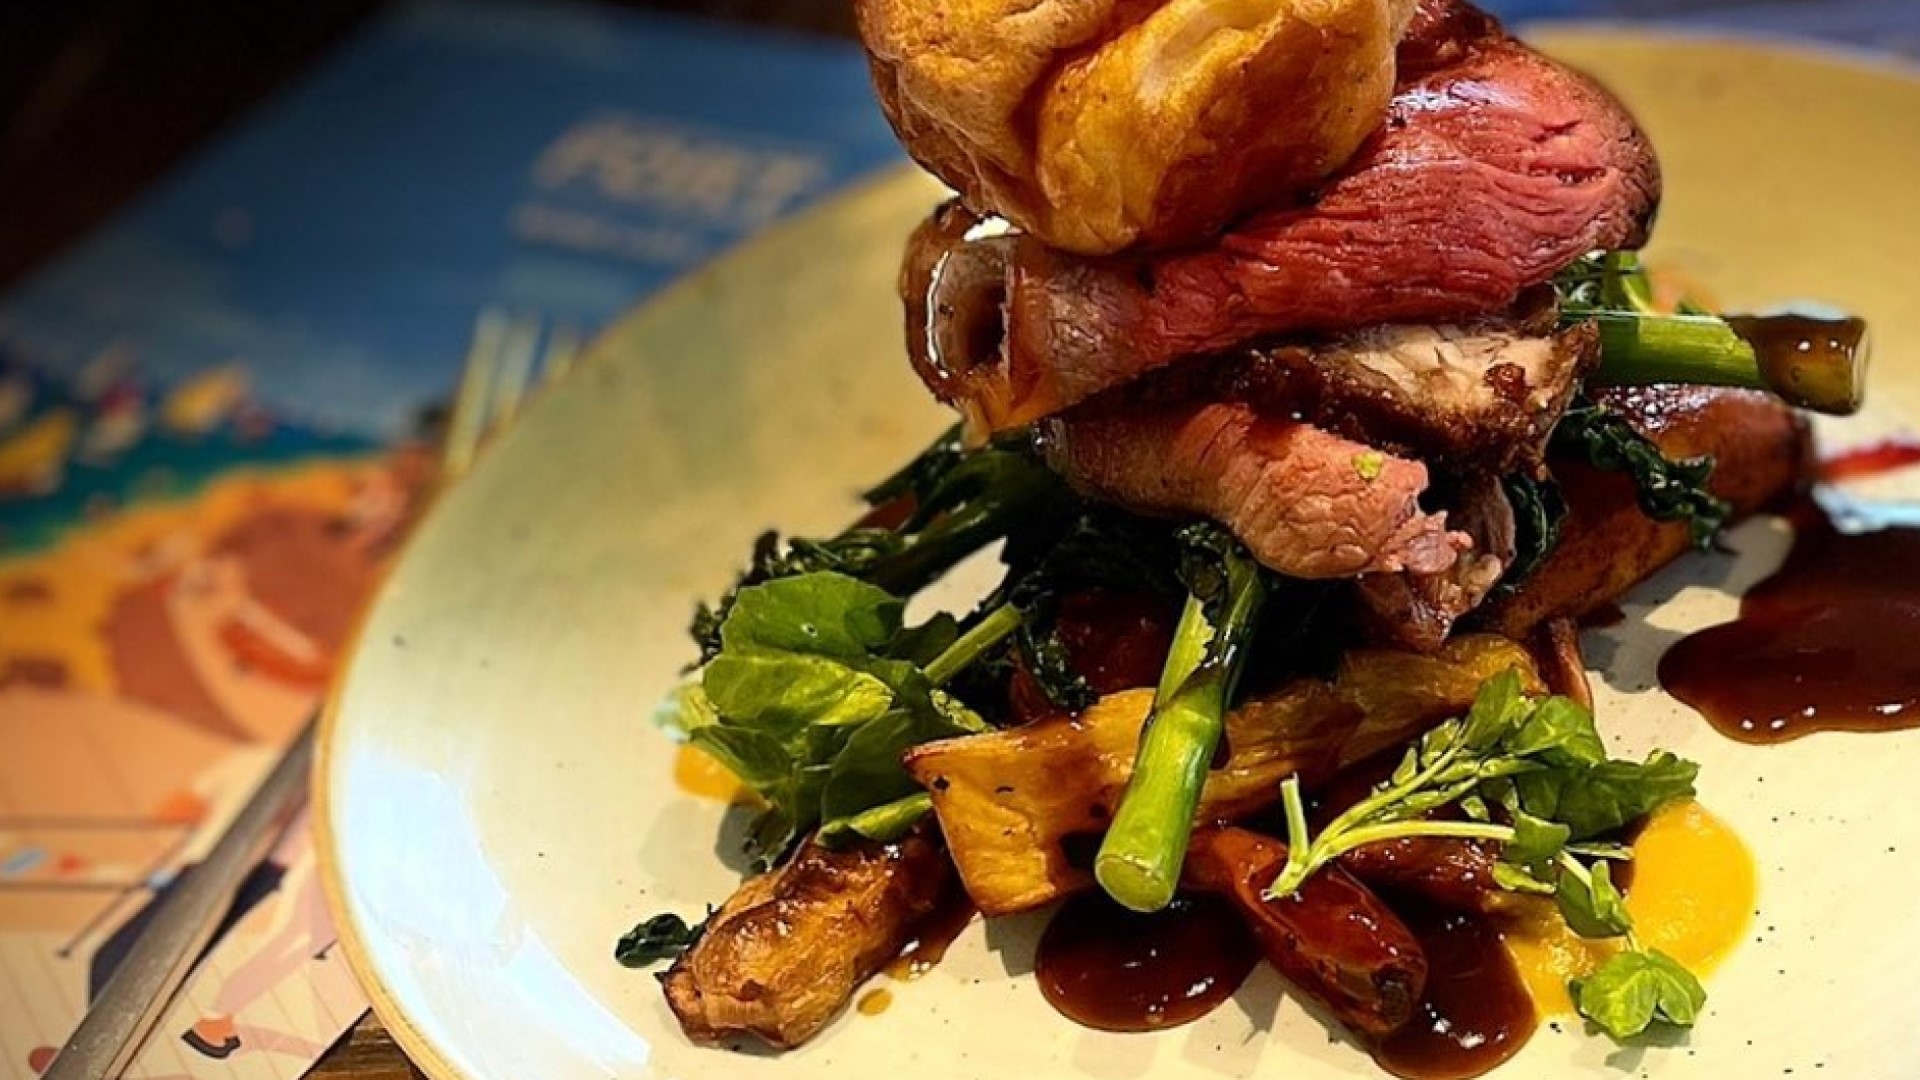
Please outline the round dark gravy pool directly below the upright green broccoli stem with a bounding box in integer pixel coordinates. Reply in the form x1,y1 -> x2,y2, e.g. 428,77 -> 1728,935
1035,892 -> 1260,1032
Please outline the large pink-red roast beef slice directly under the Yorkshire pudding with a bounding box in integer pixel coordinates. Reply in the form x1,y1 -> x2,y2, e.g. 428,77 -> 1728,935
902,35 -> 1659,430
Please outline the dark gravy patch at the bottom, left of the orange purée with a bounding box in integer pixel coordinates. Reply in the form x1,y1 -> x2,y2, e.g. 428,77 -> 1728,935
1373,905 -> 1538,1080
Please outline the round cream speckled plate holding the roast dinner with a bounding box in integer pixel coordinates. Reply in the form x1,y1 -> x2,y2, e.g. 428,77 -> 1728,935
319,33 -> 1920,1080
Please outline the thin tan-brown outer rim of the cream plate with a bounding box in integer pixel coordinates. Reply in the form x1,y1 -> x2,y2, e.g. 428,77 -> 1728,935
309,33 -> 1920,1080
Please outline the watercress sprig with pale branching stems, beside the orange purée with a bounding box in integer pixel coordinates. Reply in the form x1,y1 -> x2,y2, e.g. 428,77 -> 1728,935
1267,671 -> 1705,1038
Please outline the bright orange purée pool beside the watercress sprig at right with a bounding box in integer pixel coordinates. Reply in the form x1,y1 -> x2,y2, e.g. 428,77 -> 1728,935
1503,801 -> 1759,1015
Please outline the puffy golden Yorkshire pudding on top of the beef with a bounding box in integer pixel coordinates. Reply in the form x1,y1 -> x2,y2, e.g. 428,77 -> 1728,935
856,0 -> 1413,256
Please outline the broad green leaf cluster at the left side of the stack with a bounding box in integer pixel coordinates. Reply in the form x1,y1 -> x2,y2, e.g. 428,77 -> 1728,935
676,571 -> 1021,865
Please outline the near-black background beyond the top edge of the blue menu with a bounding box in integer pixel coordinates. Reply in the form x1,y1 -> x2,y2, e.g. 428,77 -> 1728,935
0,0 -> 852,290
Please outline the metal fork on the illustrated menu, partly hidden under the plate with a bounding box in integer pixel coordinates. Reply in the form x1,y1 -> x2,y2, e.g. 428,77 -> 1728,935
44,309 -> 578,1080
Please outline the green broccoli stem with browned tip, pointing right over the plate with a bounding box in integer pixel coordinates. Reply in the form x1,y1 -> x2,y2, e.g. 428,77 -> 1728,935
1578,311 -> 1866,415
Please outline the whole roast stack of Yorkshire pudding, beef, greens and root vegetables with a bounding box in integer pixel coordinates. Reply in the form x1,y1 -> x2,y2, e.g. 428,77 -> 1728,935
620,0 -> 1859,1068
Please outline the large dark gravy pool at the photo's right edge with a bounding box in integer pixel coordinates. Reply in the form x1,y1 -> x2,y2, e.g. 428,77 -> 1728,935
1661,511 -> 1920,744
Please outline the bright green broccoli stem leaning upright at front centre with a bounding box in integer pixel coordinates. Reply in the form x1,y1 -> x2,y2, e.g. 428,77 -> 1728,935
1094,552 -> 1265,911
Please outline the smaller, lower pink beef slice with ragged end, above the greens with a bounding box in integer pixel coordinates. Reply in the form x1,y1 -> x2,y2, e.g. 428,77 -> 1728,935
1041,396 -> 1471,578
